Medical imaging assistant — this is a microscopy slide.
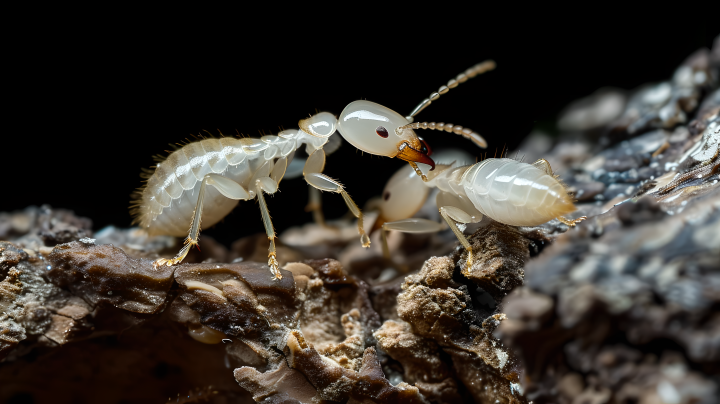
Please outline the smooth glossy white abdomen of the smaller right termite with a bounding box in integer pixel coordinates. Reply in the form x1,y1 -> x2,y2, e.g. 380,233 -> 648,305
462,159 -> 575,226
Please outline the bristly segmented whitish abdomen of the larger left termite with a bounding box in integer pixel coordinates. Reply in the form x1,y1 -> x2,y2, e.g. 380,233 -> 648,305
131,130 -> 328,237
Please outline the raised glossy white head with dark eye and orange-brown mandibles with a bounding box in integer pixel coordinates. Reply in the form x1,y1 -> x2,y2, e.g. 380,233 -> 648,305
337,100 -> 435,170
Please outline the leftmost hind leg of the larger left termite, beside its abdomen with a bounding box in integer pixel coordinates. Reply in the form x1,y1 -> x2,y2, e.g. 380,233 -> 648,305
153,174 -> 250,268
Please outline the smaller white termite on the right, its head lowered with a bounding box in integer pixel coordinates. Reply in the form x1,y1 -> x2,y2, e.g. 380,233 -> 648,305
381,158 -> 586,268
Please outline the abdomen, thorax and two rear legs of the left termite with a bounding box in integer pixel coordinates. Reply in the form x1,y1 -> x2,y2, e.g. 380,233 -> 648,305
133,124 -> 349,279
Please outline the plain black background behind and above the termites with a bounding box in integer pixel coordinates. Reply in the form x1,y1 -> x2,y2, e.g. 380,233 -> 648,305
0,13 -> 720,244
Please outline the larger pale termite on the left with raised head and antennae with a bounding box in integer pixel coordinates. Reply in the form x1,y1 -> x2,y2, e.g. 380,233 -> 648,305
132,61 -> 495,279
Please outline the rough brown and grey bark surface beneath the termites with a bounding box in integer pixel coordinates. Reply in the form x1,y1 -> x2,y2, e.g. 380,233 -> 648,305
0,38 -> 720,404
